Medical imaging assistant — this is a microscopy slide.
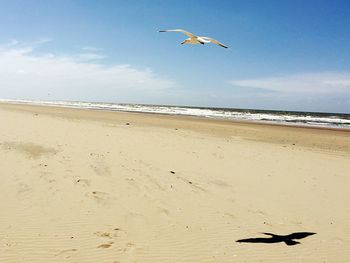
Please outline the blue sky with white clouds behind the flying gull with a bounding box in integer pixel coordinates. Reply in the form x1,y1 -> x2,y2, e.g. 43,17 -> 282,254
0,0 -> 350,113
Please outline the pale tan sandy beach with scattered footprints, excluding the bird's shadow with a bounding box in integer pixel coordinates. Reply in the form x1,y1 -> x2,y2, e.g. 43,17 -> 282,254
0,104 -> 350,263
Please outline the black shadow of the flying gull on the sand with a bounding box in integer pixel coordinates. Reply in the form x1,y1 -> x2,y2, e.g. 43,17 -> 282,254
236,232 -> 316,246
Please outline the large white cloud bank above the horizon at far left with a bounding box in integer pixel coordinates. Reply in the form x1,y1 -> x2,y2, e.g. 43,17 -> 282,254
0,42 -> 175,101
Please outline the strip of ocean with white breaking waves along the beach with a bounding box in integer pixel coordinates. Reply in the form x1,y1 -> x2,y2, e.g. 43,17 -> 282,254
0,100 -> 350,129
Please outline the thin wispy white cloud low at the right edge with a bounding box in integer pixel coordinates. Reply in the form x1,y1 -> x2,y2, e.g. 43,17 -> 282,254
230,72 -> 350,95
